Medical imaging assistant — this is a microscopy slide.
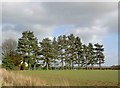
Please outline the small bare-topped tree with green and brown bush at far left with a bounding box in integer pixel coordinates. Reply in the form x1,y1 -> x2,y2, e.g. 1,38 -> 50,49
2,39 -> 21,69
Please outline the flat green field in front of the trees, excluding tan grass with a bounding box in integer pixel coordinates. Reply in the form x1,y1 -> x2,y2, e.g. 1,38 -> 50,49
19,70 -> 118,86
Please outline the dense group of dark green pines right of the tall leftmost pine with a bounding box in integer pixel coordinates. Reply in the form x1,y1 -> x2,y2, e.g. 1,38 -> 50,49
37,34 -> 103,69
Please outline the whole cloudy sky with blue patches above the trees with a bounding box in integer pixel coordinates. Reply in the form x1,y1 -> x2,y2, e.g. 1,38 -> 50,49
0,2 -> 118,65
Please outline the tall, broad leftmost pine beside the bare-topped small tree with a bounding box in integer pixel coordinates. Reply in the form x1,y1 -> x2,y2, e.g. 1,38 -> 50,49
17,31 -> 38,70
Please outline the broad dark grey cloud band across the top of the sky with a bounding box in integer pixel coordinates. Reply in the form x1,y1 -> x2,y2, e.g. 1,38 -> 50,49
3,2 -> 117,26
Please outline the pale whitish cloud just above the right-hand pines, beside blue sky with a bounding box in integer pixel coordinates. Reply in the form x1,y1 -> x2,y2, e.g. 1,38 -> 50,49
68,26 -> 108,44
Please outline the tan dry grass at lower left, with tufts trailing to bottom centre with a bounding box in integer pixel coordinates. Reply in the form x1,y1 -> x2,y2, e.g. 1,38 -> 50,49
0,69 -> 69,87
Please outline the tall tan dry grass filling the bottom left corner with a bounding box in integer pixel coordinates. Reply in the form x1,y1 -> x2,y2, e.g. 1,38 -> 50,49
0,70 -> 47,86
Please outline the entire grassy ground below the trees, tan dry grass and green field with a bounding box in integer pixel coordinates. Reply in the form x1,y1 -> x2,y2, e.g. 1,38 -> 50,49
0,69 -> 118,86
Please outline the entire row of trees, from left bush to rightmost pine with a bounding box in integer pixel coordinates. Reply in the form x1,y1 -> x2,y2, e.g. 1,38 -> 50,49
2,31 -> 104,70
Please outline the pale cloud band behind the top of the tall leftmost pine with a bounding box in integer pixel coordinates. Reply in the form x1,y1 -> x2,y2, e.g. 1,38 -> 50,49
2,24 -> 56,41
